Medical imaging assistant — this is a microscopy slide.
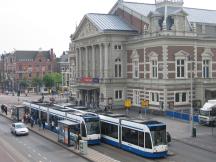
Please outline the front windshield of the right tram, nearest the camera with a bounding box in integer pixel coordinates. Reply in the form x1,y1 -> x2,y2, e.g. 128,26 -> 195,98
150,126 -> 166,146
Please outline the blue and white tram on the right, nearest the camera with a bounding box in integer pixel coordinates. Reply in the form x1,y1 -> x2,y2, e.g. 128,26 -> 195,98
99,114 -> 168,158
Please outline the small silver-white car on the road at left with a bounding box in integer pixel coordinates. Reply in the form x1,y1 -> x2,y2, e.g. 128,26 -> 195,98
10,122 -> 29,136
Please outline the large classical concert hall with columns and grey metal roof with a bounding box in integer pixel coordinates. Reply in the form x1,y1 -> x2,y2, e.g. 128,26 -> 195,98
71,0 -> 216,110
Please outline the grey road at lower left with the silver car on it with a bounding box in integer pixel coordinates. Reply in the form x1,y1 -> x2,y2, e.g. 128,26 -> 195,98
0,116 -> 86,162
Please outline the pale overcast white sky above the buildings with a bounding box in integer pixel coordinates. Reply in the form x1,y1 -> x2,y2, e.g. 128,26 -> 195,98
0,0 -> 216,56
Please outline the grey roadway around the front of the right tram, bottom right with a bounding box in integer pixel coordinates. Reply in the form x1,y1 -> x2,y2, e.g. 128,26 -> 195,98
92,141 -> 216,162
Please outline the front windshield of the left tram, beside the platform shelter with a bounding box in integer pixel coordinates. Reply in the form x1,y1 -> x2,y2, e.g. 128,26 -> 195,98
85,118 -> 100,135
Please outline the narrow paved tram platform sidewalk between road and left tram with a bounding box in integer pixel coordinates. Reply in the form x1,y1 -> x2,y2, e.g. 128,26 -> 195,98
0,113 -> 119,162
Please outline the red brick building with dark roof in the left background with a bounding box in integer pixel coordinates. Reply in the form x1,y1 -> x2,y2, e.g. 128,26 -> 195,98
4,49 -> 56,91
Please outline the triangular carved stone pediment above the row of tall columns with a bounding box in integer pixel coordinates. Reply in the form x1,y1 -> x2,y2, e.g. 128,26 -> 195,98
74,17 -> 99,39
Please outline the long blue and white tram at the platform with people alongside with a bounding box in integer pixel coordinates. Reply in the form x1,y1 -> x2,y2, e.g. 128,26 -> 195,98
23,102 -> 101,145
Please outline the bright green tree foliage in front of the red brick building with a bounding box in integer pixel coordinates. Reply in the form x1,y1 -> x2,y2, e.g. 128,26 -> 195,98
43,73 -> 62,88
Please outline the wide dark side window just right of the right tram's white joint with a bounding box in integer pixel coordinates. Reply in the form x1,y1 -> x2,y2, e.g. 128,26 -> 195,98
122,127 -> 138,145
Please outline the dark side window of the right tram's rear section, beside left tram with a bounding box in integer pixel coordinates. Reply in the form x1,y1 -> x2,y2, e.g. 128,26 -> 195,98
101,122 -> 118,139
